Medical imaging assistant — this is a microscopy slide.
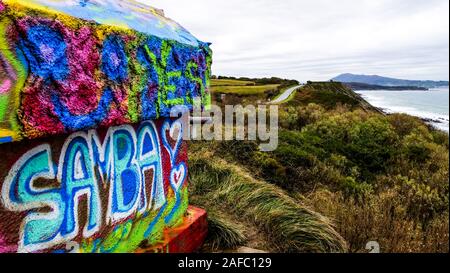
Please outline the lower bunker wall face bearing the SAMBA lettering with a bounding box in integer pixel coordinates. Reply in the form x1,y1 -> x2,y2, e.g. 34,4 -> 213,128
0,119 -> 187,252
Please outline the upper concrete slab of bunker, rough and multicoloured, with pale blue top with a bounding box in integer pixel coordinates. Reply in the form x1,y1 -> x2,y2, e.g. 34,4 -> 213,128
0,0 -> 211,143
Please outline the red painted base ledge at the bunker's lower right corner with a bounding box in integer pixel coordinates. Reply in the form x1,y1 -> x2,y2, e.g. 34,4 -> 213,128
136,206 -> 208,253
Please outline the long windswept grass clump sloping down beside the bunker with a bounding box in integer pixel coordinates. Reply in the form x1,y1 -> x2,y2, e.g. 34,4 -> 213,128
189,150 -> 347,252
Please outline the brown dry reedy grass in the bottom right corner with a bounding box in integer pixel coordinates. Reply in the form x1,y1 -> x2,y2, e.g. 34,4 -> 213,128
304,190 -> 449,253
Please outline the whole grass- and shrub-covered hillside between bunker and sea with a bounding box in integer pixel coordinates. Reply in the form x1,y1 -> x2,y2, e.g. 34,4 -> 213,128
190,79 -> 449,252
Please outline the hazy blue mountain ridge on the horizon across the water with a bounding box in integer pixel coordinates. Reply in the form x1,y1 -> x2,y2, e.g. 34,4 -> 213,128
332,73 -> 448,88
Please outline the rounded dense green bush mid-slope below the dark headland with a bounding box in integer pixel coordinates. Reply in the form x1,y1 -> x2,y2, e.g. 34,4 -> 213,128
302,111 -> 398,181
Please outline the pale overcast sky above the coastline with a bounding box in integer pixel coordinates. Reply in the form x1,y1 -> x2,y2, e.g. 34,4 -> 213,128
140,0 -> 449,81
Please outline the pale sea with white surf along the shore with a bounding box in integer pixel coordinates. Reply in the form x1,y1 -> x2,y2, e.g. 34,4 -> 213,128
356,88 -> 449,133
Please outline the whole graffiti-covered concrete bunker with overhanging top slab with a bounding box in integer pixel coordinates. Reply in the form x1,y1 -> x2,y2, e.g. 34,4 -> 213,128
0,0 -> 212,253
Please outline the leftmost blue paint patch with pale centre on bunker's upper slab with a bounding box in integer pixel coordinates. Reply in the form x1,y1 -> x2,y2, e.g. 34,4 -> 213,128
20,25 -> 69,81
